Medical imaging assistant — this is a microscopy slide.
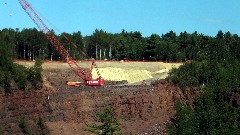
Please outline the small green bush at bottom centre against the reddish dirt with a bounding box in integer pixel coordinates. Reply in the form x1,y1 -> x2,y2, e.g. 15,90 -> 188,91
85,107 -> 121,135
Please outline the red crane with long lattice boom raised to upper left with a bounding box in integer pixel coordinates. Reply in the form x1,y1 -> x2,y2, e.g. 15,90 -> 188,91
18,0 -> 104,86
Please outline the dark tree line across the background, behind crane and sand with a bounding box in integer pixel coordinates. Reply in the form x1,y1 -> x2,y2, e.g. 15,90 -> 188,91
0,28 -> 240,62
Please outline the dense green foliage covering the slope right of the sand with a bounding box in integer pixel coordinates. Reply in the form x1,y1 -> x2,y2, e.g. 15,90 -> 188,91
168,57 -> 240,134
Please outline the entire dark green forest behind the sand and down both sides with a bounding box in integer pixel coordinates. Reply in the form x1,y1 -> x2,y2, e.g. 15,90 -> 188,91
0,28 -> 240,135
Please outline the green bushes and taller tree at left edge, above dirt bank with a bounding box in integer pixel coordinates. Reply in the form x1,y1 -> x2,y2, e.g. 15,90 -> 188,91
0,30 -> 42,93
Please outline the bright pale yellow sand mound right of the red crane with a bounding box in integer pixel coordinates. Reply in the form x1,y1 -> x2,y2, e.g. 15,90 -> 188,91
93,62 -> 182,83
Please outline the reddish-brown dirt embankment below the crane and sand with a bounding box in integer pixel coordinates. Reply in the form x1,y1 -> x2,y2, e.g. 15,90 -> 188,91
0,61 -> 196,135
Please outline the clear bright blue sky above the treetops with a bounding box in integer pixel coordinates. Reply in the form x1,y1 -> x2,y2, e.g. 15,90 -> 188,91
0,0 -> 240,37
